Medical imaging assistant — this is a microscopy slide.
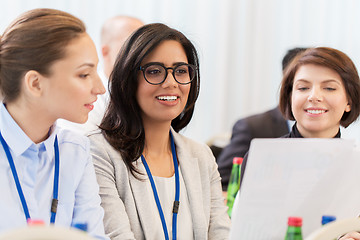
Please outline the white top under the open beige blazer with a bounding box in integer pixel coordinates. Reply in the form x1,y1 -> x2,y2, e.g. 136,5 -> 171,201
150,168 -> 194,240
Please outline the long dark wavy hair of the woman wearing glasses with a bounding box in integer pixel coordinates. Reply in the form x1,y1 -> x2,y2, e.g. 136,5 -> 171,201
100,23 -> 200,176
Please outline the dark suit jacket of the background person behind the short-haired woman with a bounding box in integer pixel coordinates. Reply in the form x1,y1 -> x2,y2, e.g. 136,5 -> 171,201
217,107 -> 289,191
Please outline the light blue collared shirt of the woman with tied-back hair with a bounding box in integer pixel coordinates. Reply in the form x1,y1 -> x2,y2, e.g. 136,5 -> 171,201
0,103 -> 108,239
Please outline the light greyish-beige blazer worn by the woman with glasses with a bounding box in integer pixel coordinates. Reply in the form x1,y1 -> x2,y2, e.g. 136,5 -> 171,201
89,131 -> 230,240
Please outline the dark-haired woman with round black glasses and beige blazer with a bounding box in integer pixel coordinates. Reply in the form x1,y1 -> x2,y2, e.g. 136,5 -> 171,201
90,24 -> 230,240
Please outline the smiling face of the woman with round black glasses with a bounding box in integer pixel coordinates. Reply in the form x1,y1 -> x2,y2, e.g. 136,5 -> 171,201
136,40 -> 191,124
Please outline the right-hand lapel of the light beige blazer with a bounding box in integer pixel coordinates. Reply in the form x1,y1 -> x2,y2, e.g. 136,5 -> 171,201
173,131 -> 208,239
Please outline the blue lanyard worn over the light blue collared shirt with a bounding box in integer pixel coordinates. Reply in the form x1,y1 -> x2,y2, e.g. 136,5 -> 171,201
0,132 -> 59,223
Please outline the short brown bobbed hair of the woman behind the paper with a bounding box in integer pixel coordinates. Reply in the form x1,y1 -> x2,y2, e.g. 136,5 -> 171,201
279,47 -> 360,127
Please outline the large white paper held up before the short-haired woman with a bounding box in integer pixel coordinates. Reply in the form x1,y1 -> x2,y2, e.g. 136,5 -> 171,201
230,138 -> 360,240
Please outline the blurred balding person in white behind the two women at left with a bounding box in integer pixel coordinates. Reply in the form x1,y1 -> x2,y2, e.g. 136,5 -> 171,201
57,16 -> 144,134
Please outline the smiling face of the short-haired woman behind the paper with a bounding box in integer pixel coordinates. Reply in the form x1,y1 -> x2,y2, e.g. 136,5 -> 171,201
291,64 -> 351,138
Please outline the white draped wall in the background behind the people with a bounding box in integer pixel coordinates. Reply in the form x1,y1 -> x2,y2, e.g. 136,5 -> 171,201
0,0 -> 360,141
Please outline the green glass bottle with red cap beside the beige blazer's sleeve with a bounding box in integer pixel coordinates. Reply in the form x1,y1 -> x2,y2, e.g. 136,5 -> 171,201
226,157 -> 243,218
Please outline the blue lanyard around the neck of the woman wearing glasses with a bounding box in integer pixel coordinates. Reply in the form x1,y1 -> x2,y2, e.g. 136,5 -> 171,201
141,132 -> 180,240
